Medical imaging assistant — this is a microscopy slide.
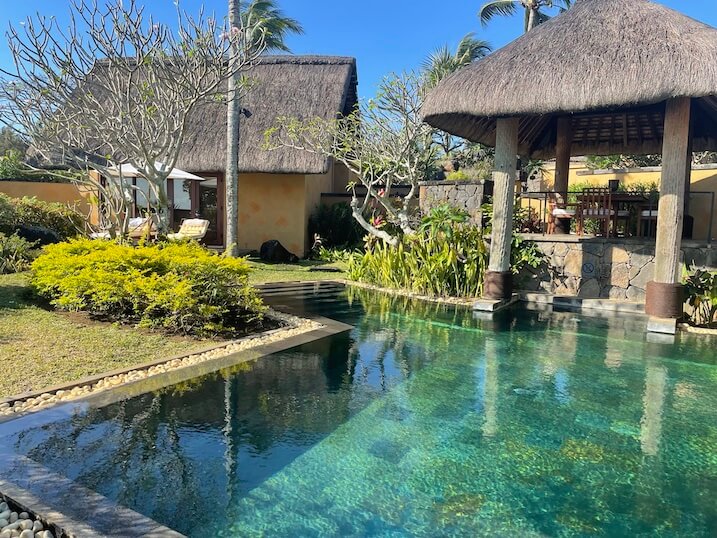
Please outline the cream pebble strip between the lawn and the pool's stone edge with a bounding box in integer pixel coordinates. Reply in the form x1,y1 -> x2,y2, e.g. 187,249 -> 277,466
0,310 -> 323,416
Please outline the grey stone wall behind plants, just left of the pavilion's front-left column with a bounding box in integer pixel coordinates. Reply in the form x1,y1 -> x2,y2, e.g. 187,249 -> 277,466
419,180 -> 493,226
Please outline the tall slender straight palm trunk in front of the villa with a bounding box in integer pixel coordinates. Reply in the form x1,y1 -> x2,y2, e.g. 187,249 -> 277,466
225,0 -> 241,256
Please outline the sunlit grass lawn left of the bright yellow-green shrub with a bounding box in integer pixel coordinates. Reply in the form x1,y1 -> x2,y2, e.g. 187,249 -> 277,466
0,274 -> 211,397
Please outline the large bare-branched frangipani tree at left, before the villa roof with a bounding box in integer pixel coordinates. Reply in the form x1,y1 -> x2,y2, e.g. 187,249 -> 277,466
0,0 -> 265,231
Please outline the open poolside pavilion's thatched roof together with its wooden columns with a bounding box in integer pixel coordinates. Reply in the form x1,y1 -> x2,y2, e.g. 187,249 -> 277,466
423,0 -> 717,326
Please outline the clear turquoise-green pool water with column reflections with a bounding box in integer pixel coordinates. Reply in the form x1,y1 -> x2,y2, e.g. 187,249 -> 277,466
2,284 -> 717,537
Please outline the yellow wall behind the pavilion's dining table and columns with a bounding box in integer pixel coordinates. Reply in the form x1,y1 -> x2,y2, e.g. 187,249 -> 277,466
540,163 -> 717,239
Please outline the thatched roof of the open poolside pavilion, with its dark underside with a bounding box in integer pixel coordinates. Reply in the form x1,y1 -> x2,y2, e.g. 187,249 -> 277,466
423,0 -> 717,158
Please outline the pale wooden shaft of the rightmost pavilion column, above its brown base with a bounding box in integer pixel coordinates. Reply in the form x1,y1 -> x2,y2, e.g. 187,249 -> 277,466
655,97 -> 691,284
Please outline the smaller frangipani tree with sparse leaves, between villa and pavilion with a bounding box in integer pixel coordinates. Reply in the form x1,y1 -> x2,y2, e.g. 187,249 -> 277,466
266,74 -> 439,245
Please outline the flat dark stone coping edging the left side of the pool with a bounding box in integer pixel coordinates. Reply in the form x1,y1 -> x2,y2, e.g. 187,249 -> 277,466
0,282 -> 353,538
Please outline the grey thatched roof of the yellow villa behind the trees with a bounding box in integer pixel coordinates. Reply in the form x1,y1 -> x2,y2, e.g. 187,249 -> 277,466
177,56 -> 357,174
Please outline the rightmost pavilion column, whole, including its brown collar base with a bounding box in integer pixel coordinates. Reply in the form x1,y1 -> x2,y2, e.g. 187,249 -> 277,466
645,97 -> 691,319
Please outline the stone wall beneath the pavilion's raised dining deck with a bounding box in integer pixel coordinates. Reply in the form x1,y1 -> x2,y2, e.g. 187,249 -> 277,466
519,235 -> 717,302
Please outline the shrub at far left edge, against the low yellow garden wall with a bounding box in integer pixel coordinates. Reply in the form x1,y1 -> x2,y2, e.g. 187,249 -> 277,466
0,193 -> 84,239
